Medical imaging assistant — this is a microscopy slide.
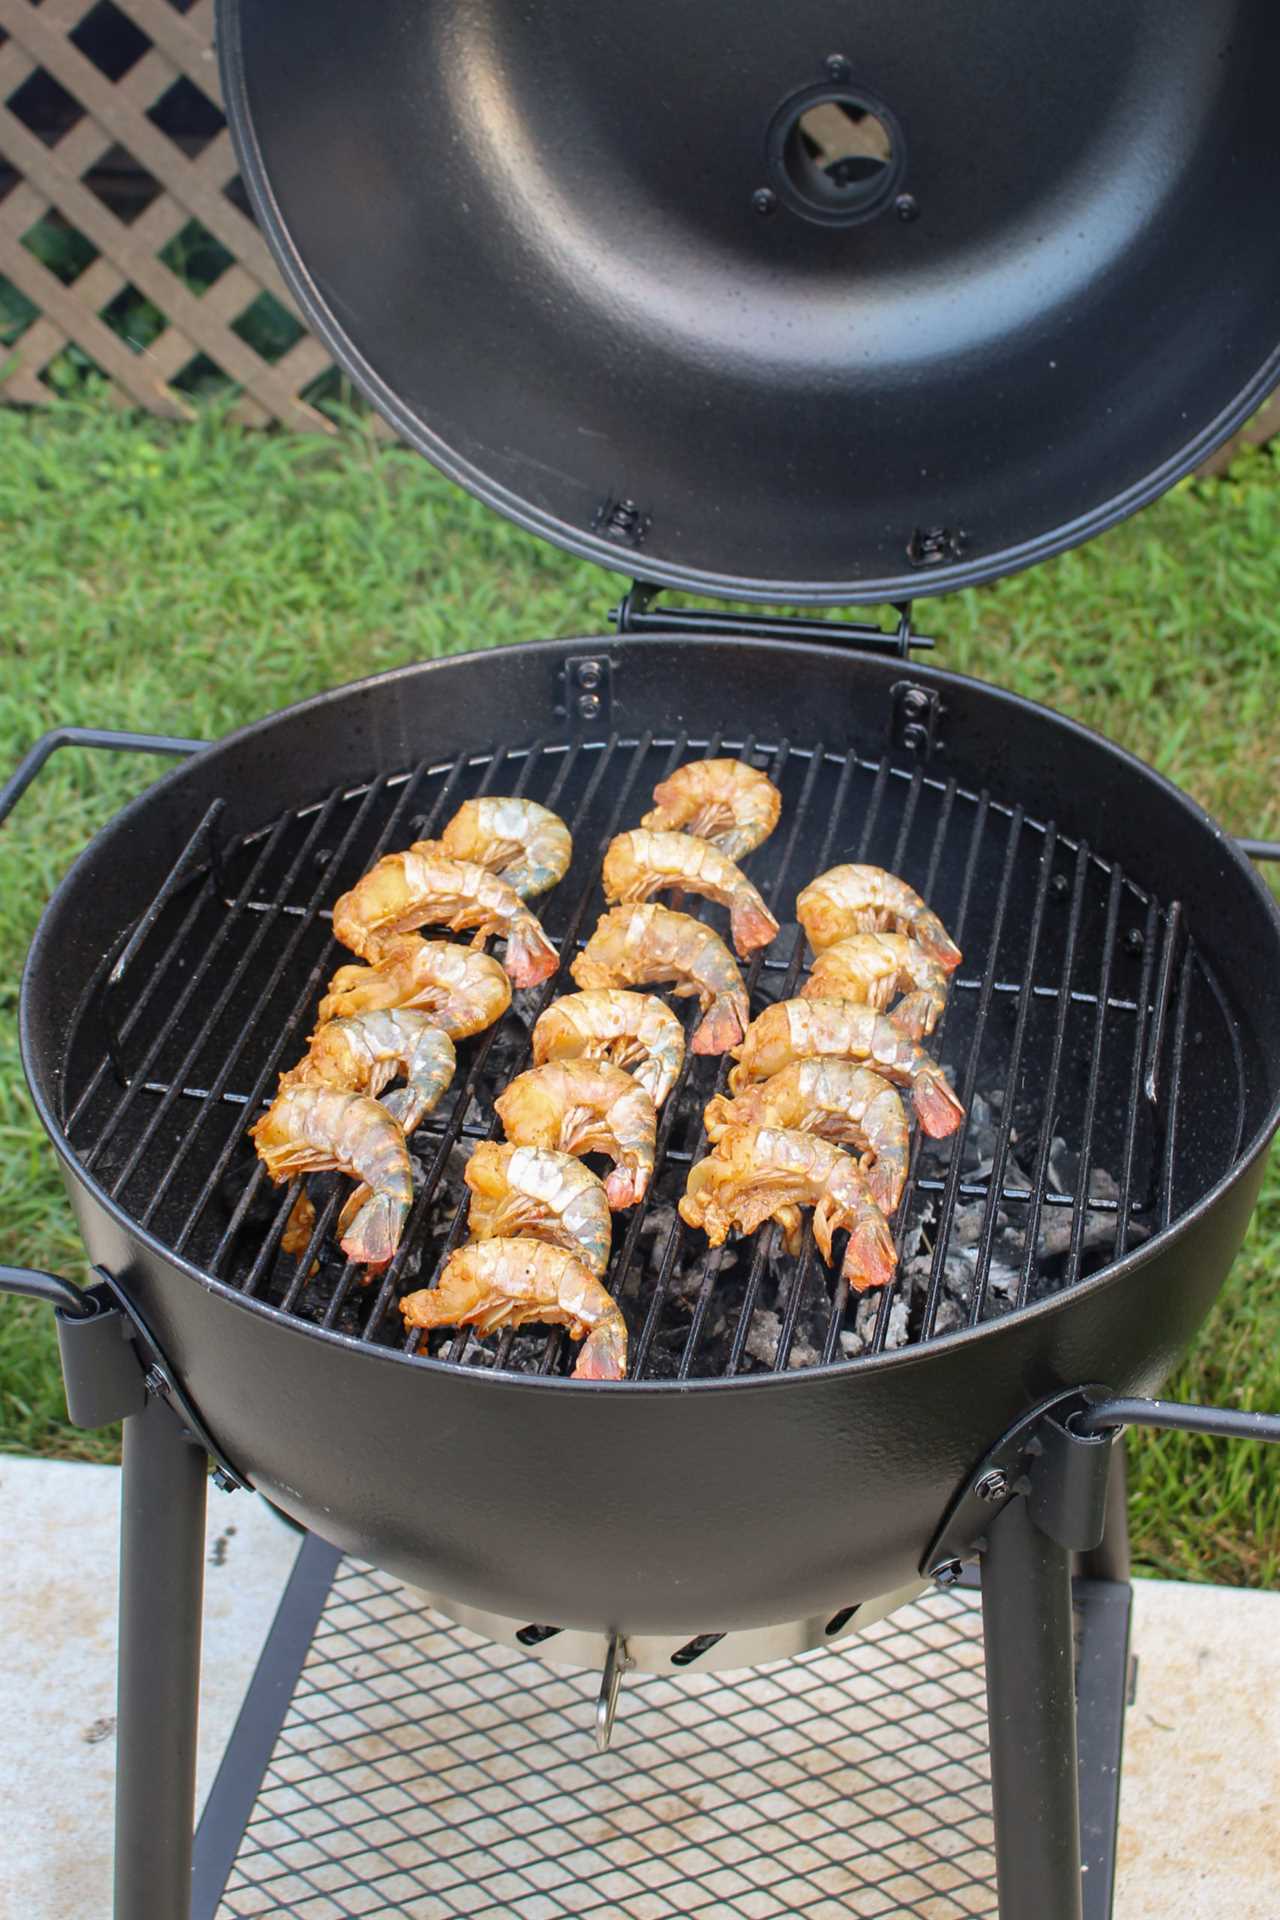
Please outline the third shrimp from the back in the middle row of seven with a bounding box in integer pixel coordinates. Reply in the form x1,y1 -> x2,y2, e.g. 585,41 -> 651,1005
570,906 -> 750,1054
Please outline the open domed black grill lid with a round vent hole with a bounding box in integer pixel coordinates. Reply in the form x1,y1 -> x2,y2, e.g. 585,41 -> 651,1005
219,0 -> 1280,603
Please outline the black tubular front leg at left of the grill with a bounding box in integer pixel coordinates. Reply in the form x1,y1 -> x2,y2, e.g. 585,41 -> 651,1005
115,1398 -> 207,1920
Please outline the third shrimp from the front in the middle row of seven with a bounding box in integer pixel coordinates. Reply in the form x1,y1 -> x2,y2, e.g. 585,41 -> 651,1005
493,1059 -> 660,1212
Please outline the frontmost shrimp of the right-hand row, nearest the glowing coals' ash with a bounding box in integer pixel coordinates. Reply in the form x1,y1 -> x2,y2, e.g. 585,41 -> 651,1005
679,1127 -> 898,1292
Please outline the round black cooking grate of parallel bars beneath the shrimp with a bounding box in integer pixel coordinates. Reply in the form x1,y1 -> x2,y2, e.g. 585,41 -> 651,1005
63,733 -> 1244,1379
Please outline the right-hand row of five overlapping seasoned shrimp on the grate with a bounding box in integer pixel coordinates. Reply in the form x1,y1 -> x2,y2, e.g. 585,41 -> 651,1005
679,866 -> 963,1292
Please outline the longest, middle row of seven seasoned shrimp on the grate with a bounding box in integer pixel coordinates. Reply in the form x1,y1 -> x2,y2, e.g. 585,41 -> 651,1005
401,760 -> 781,1380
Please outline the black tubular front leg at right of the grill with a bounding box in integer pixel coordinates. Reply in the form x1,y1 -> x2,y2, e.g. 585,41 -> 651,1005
983,1498 -> 1082,1920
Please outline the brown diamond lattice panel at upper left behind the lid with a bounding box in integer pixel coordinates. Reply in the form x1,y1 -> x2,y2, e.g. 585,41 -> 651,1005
0,0 -> 332,432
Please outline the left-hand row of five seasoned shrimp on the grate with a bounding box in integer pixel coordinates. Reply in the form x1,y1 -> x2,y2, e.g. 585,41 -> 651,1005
249,797 -> 572,1271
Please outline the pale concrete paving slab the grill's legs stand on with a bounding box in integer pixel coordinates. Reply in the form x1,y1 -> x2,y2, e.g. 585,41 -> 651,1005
0,1455 -> 1280,1920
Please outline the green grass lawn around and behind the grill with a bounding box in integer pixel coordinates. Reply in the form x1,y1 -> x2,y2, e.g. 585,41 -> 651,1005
0,399 -> 1280,1584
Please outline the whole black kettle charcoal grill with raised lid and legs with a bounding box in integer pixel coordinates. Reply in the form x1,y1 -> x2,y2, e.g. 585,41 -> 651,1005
0,0 -> 1280,1920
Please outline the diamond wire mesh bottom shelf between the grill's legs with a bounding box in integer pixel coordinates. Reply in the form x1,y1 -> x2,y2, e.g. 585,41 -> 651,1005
198,1561 -> 996,1920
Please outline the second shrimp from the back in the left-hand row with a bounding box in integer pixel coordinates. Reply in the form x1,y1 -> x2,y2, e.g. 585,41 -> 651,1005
334,841 -> 558,987
